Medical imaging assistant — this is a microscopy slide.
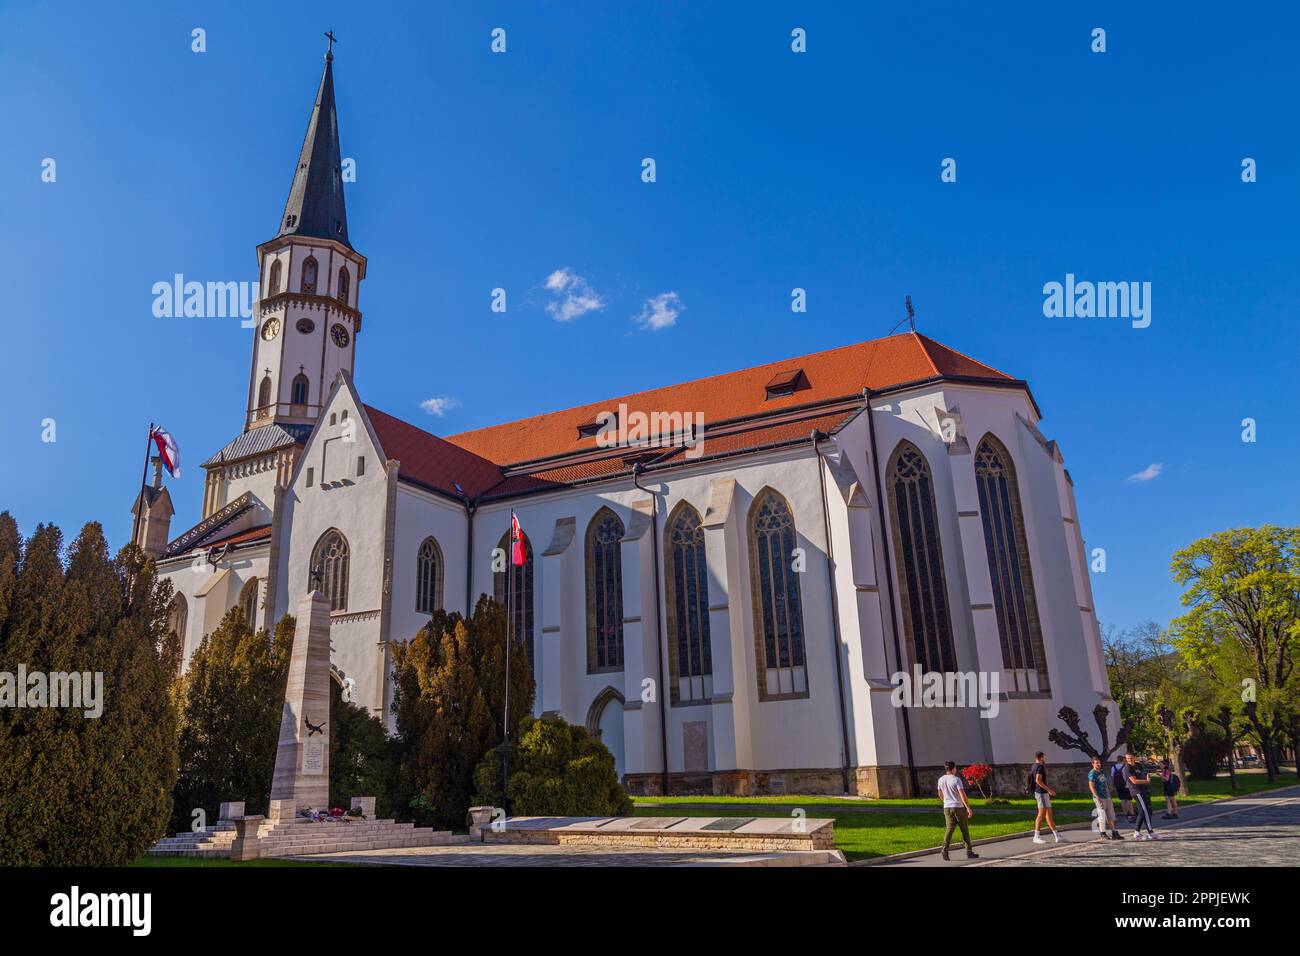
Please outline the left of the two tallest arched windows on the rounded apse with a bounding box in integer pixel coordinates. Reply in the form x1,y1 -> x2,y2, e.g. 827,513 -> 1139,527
887,441 -> 957,672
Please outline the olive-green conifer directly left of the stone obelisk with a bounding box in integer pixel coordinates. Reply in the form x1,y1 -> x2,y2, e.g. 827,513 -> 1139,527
172,607 -> 295,831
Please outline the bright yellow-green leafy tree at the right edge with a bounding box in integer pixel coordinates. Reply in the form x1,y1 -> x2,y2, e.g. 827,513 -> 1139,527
1170,524 -> 1300,780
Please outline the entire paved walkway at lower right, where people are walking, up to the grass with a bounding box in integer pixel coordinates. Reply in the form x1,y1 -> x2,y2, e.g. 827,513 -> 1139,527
876,787 -> 1300,866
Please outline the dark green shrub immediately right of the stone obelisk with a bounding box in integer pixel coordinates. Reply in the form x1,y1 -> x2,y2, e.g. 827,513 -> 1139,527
329,680 -> 404,818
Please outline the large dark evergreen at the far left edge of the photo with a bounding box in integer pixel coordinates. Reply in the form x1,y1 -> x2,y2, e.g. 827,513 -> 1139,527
0,514 -> 179,866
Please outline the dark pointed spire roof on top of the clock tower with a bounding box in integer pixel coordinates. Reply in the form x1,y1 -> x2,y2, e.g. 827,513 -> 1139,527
278,53 -> 352,248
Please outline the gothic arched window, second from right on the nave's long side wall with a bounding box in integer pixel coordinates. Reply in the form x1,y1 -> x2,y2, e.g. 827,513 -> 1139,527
664,502 -> 714,704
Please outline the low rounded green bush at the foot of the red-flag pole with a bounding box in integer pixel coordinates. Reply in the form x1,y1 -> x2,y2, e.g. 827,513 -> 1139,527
475,717 -> 632,817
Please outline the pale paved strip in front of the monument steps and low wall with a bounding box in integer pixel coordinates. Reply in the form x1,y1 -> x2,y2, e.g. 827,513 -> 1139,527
293,843 -> 820,866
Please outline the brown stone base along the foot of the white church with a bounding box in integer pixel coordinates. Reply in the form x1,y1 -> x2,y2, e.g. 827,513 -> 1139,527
623,763 -> 1092,800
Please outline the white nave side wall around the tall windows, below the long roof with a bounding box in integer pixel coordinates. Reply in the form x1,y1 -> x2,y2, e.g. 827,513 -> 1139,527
475,446 -> 841,773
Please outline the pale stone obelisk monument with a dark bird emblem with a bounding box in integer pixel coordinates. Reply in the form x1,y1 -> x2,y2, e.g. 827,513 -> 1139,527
268,591 -> 330,822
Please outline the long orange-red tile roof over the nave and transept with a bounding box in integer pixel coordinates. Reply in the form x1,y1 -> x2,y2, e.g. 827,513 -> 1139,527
365,332 -> 1023,498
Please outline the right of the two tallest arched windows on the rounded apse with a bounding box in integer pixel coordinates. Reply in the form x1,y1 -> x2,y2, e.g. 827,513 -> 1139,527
975,434 -> 1050,692
